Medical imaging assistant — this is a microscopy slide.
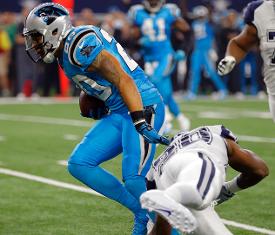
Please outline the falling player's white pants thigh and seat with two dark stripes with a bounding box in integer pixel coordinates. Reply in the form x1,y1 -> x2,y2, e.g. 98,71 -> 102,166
157,152 -> 225,210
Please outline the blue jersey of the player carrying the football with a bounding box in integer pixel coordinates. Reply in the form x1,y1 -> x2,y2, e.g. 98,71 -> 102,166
59,25 -> 161,112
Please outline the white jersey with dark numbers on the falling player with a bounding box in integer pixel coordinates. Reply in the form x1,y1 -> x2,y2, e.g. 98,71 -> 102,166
150,125 -> 237,180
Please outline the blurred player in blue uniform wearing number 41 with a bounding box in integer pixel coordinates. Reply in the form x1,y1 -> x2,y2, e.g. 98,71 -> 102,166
128,0 -> 190,130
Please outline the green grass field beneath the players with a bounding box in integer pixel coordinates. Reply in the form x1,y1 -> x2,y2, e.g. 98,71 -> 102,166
0,96 -> 275,235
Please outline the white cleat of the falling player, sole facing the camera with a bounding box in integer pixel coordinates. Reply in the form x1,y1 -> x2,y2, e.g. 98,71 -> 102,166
140,190 -> 197,233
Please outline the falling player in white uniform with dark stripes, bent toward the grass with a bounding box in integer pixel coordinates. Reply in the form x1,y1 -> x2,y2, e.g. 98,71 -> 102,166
140,125 -> 268,235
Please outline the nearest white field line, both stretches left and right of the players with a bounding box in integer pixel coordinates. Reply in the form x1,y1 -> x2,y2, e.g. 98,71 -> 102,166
0,168 -> 275,235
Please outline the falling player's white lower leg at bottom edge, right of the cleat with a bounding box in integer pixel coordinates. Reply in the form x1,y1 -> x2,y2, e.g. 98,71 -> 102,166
191,206 -> 233,235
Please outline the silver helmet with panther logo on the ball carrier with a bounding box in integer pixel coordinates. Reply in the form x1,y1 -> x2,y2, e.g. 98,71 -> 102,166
23,3 -> 72,63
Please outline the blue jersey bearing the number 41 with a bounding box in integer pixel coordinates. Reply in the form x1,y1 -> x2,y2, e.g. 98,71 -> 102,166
128,4 -> 180,60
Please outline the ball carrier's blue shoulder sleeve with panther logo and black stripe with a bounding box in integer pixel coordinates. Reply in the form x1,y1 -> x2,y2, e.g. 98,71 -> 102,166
68,28 -> 103,69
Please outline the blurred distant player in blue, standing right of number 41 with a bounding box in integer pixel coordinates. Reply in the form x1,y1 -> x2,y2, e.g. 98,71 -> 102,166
186,5 -> 227,100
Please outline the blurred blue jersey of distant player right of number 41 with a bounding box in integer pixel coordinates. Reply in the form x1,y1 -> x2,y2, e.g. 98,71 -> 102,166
192,20 -> 214,50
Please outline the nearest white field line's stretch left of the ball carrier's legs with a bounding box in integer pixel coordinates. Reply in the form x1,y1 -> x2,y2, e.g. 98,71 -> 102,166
0,168 -> 103,197
